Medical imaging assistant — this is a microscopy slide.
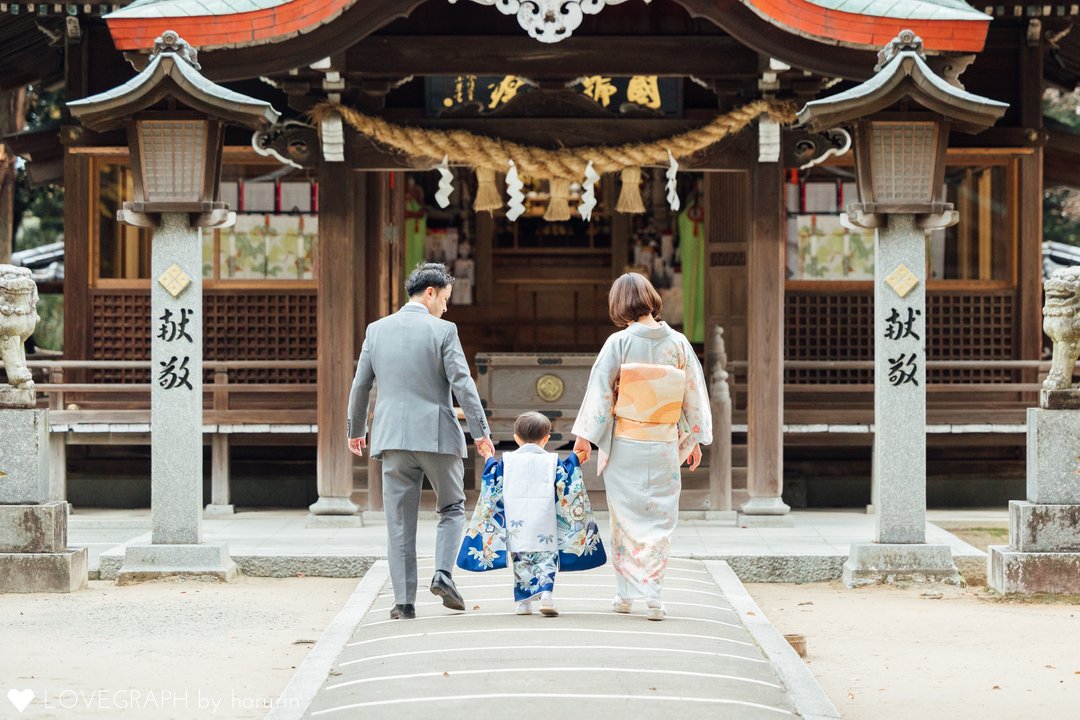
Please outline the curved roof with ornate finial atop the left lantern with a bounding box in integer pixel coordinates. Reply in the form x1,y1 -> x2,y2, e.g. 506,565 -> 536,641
67,30 -> 280,132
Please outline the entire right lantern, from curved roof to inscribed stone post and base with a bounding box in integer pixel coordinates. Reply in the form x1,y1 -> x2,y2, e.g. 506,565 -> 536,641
798,30 -> 1008,586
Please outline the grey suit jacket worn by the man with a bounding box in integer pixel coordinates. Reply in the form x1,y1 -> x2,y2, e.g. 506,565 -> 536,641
349,305 -> 490,458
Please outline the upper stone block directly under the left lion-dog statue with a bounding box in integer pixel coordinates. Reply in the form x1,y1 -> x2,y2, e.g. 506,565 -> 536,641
0,408 -> 49,505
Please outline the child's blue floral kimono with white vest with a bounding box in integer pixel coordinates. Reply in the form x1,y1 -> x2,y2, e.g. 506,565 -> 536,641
458,445 -> 607,602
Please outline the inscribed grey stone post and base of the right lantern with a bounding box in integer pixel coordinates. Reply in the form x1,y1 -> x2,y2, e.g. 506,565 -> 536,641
843,214 -> 959,587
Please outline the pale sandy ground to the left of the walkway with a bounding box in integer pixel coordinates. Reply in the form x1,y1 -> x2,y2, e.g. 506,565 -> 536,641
0,576 -> 359,720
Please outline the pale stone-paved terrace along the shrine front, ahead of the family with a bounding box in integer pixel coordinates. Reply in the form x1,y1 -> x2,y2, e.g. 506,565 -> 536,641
69,510 -> 993,582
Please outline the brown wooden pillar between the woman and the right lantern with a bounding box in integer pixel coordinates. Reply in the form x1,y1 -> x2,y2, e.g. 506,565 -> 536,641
740,162 -> 791,515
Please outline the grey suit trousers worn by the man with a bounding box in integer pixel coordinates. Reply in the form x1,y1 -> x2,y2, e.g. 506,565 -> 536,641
381,450 -> 465,604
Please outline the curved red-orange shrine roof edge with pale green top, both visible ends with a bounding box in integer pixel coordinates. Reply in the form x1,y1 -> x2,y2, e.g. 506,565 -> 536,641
106,0 -> 990,53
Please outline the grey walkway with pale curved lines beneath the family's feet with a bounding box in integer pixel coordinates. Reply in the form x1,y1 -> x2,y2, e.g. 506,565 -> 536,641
268,559 -> 839,720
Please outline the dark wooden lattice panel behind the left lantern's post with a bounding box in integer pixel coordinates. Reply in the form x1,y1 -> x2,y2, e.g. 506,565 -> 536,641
91,289 -> 318,382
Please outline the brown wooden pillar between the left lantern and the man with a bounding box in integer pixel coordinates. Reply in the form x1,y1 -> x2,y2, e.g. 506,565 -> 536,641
311,161 -> 359,515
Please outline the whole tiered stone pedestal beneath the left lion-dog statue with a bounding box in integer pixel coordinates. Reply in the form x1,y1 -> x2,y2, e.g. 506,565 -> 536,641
0,403 -> 87,593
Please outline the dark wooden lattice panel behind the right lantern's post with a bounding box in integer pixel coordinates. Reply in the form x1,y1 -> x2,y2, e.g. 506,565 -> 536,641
784,289 -> 1016,383
